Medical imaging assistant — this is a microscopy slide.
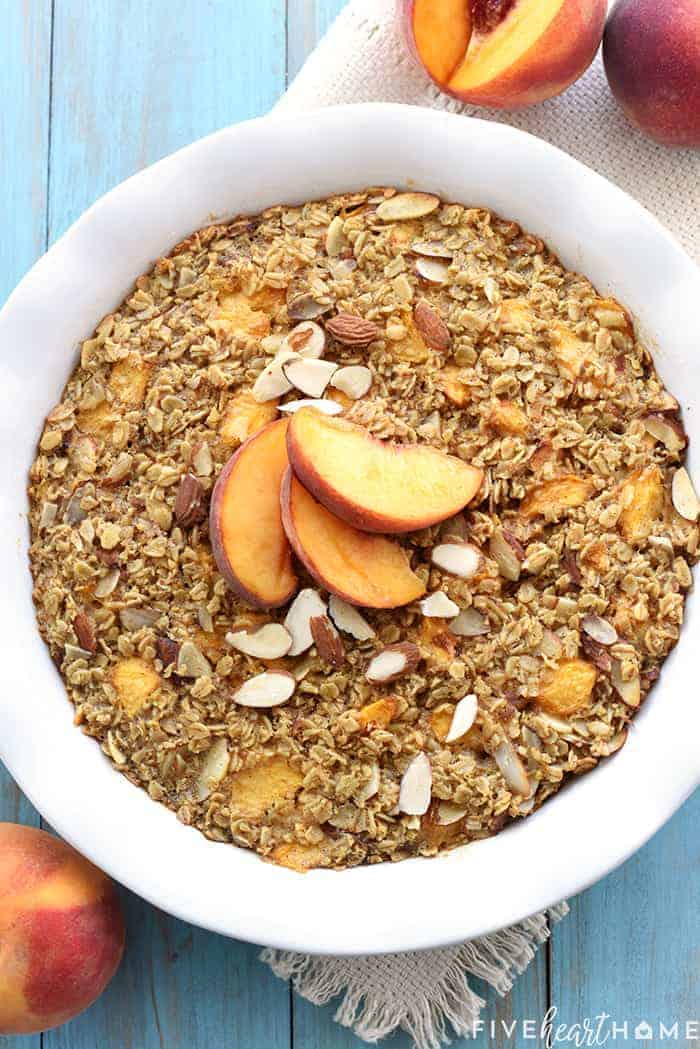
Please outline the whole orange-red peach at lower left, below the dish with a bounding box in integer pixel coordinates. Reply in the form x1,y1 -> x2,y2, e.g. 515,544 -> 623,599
0,823 -> 124,1034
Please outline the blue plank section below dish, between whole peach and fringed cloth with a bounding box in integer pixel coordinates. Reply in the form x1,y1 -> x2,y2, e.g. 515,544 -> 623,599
48,887 -> 290,1049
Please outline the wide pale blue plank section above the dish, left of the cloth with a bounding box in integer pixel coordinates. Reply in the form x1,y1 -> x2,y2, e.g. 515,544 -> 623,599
49,0 -> 284,237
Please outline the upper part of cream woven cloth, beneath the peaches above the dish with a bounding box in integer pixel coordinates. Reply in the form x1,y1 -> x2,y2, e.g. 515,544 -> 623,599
277,0 -> 700,262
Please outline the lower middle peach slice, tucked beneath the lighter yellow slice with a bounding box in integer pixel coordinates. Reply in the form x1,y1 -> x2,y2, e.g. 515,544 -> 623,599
281,470 -> 425,608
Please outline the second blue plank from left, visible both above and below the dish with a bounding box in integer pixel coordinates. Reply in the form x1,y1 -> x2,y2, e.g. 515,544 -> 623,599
39,0 -> 290,1049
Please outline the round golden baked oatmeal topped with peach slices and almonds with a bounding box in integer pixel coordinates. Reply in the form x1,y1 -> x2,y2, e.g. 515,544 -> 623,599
29,189 -> 700,871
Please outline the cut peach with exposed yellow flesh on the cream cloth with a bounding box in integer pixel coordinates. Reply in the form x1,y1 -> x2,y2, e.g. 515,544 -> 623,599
399,0 -> 607,109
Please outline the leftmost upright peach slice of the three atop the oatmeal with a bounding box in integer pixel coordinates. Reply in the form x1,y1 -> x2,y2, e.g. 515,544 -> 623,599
209,419 -> 297,608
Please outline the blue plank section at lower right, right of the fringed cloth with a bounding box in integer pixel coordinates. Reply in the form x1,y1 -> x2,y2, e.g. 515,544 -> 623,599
552,793 -> 700,1045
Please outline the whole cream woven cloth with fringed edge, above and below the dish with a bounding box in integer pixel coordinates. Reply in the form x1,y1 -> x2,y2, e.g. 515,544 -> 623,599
262,0 -> 700,1049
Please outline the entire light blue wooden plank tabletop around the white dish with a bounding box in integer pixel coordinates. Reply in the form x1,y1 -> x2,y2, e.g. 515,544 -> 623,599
0,0 -> 700,1049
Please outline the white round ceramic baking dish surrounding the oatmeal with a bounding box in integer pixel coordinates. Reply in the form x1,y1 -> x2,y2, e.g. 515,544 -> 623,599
0,105 -> 700,954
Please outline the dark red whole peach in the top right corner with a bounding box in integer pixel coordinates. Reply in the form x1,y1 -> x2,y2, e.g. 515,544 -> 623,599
602,0 -> 700,148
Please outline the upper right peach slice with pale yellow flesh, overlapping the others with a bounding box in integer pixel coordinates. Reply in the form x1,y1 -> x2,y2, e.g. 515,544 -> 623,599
287,408 -> 483,533
